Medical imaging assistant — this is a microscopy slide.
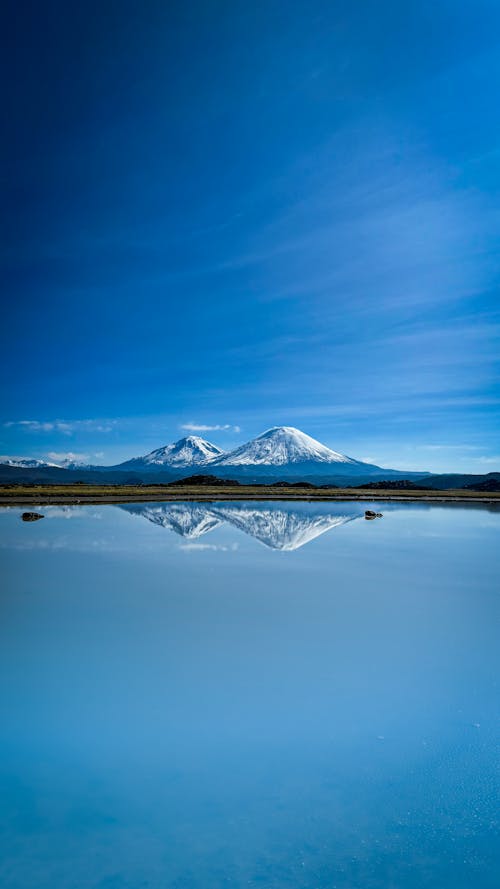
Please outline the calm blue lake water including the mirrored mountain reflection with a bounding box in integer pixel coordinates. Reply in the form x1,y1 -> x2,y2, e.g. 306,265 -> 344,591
0,503 -> 500,889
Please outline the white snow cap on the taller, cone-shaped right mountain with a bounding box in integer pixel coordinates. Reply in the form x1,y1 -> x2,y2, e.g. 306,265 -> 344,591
214,426 -> 359,467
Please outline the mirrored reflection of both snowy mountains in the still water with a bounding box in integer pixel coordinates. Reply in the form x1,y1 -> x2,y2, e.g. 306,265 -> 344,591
120,502 -> 362,552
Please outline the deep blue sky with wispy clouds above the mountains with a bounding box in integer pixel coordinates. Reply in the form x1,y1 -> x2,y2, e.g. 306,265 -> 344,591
0,0 -> 500,472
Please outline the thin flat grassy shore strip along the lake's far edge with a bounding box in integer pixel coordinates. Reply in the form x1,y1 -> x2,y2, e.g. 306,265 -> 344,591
0,485 -> 500,506
